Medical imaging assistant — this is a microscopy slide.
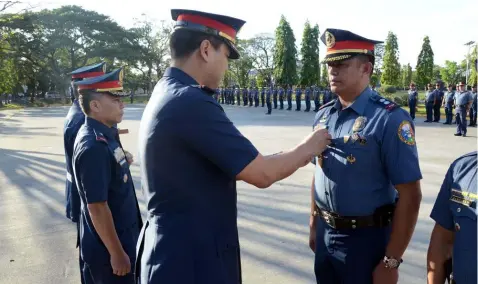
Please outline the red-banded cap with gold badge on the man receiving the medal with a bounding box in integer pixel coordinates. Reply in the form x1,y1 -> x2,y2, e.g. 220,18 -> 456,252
320,29 -> 383,63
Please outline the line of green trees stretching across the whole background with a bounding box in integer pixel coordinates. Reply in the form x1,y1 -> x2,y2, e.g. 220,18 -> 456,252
0,1 -> 476,100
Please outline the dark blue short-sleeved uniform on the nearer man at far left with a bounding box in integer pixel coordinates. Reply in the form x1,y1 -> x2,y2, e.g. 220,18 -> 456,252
73,117 -> 142,266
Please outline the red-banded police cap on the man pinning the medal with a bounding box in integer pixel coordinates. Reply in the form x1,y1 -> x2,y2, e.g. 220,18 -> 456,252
171,9 -> 245,59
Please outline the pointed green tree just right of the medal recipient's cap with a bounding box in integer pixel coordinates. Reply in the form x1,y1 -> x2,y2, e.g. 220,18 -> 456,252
380,32 -> 400,86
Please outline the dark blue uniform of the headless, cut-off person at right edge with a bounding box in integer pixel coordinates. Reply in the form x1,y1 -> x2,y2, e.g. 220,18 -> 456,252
430,151 -> 478,284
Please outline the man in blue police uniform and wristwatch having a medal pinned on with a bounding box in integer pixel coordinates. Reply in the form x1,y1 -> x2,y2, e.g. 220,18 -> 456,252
309,29 -> 422,284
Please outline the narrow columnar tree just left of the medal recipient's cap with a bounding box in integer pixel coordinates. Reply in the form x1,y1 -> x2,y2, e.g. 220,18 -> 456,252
300,21 -> 320,86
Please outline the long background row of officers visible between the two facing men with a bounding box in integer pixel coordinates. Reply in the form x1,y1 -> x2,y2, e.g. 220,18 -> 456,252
214,86 -> 337,114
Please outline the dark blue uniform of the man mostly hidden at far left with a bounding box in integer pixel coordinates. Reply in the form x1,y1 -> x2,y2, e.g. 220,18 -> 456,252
63,100 -> 85,222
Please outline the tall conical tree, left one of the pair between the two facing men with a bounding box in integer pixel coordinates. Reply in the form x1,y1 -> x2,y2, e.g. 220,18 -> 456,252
273,15 -> 297,85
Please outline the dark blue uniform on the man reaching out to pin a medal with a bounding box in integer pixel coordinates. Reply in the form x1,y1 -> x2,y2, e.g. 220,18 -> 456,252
138,68 -> 260,284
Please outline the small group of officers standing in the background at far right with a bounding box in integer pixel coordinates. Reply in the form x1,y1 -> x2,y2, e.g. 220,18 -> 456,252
408,82 -> 478,137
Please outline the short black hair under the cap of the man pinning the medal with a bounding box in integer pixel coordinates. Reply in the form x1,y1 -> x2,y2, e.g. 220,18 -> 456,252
169,29 -> 225,60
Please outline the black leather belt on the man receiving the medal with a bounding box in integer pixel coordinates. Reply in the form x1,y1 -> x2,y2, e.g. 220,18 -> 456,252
315,204 -> 395,230
